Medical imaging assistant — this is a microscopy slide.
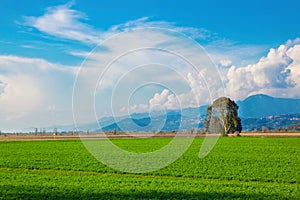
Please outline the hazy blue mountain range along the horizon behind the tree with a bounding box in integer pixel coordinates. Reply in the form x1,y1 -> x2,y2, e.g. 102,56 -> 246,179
22,94 -> 300,132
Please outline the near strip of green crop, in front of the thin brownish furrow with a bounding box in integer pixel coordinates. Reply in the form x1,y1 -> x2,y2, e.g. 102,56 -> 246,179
0,169 -> 299,200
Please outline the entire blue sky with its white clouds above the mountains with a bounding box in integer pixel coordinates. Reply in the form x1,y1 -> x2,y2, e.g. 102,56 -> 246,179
0,0 -> 300,131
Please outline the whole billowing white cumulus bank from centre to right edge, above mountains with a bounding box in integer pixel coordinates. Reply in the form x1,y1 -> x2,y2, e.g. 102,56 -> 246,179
127,39 -> 300,114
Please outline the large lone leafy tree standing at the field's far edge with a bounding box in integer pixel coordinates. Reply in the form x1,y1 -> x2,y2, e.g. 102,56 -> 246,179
204,97 -> 242,135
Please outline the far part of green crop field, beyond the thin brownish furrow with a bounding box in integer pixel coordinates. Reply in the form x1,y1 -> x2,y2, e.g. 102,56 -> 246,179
0,138 -> 300,183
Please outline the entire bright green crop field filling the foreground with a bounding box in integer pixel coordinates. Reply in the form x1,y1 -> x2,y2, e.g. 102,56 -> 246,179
0,137 -> 300,199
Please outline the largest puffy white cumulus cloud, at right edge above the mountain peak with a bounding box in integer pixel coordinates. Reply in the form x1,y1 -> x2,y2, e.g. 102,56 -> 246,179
226,39 -> 300,99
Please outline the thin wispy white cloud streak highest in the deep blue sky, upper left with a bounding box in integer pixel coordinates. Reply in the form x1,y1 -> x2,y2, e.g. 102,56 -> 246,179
20,2 -> 214,46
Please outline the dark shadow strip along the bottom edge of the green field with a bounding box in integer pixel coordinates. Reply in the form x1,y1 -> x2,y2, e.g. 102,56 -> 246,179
0,186 -> 283,199
